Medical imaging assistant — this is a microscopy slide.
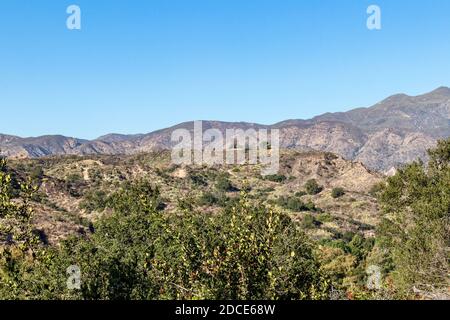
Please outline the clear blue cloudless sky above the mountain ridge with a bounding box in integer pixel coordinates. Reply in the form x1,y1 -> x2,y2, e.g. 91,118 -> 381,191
0,0 -> 450,138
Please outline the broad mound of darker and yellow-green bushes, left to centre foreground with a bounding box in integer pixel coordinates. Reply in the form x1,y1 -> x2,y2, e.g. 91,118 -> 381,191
15,189 -> 328,299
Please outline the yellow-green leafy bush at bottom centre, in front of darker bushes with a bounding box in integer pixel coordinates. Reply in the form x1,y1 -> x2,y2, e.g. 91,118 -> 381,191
153,195 -> 325,299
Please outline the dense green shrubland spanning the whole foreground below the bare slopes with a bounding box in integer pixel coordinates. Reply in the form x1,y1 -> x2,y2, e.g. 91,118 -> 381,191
0,140 -> 450,299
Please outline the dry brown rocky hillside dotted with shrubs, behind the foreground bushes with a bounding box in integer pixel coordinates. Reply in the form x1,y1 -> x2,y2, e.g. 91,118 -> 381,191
9,150 -> 382,243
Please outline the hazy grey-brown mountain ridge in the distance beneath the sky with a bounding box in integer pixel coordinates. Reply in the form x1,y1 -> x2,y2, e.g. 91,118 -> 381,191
0,87 -> 450,171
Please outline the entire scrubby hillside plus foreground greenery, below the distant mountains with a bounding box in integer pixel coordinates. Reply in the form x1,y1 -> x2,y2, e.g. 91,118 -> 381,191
0,137 -> 450,299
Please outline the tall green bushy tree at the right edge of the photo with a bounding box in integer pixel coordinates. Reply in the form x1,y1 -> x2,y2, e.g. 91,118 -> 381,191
378,139 -> 450,295
